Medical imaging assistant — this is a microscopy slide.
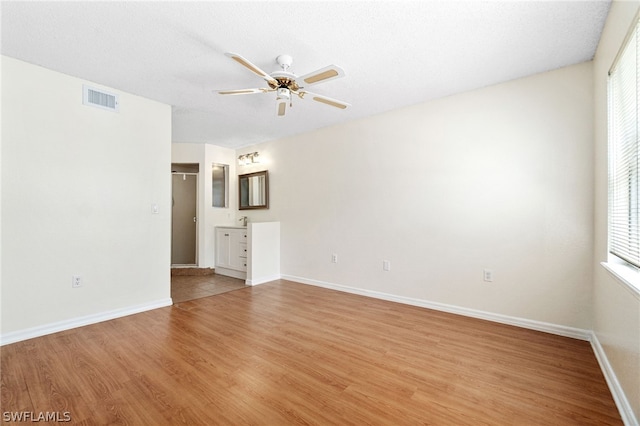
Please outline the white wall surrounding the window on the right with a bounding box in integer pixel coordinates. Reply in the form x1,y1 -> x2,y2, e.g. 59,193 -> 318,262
593,1 -> 640,421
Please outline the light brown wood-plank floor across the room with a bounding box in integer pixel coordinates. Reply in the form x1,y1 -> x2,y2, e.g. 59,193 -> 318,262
0,281 -> 622,425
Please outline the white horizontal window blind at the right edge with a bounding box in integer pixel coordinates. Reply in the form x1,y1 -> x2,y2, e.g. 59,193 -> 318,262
608,20 -> 640,267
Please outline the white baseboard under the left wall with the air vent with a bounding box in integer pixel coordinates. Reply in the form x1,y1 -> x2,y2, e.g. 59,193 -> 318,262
0,298 -> 173,346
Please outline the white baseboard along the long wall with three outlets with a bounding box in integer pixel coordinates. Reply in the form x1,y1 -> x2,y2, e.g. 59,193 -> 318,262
282,275 -> 591,341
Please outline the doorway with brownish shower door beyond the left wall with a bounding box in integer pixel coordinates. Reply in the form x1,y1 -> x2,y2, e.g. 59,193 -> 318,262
171,164 -> 199,266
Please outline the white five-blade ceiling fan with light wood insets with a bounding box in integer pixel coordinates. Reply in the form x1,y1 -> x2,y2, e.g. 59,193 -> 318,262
218,53 -> 351,117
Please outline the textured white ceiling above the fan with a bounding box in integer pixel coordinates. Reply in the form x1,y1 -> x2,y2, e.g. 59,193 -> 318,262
0,0 -> 610,148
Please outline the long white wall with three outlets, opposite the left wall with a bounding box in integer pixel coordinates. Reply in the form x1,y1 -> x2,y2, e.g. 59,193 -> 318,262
239,63 -> 593,329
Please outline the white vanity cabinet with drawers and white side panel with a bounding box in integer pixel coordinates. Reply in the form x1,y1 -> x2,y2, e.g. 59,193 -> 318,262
215,222 -> 280,285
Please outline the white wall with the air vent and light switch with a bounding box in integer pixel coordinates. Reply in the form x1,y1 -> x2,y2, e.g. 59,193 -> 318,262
1,56 -> 171,342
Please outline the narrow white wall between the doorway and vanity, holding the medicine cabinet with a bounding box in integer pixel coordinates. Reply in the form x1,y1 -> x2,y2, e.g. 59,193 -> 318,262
171,143 -> 239,268
